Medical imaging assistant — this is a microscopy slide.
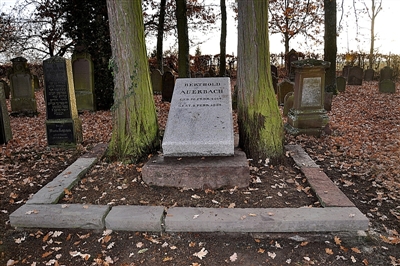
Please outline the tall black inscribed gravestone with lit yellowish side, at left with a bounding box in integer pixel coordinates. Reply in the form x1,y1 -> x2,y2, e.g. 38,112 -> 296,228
43,56 -> 82,147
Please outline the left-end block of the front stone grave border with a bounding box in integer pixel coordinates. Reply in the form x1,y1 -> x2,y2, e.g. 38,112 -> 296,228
10,204 -> 110,229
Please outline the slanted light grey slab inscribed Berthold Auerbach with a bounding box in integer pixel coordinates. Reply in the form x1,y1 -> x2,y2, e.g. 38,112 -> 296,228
162,78 -> 234,157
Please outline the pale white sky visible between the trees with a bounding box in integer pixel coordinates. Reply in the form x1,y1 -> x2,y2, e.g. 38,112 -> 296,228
0,0 -> 400,55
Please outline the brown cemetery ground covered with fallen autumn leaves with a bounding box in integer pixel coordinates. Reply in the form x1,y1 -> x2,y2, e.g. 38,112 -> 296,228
0,82 -> 400,266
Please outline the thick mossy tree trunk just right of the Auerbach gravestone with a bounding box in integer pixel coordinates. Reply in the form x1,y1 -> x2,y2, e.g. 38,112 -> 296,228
237,0 -> 284,161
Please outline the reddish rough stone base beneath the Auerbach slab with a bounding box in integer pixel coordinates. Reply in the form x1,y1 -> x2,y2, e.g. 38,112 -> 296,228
142,150 -> 250,189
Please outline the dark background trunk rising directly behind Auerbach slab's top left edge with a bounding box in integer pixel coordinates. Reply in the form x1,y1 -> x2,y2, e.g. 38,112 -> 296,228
176,0 -> 190,78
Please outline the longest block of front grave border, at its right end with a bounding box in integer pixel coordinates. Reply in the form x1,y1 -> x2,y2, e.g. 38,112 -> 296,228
165,207 -> 369,233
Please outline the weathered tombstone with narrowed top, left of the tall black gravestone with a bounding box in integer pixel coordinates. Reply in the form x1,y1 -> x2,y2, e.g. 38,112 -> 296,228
9,57 -> 37,115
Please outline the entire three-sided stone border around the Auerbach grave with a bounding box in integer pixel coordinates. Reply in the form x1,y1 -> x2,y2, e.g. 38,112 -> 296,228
9,144 -> 369,234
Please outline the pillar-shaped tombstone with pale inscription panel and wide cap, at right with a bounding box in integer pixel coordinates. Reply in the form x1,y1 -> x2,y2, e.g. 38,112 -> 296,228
285,59 -> 330,136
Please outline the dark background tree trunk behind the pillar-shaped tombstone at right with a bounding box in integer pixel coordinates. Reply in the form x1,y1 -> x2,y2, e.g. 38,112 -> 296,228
324,0 -> 337,93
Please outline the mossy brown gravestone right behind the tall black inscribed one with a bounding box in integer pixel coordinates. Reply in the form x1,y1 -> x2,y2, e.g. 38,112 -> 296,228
72,52 -> 96,111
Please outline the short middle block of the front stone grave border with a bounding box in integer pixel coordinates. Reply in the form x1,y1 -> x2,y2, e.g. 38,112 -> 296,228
105,206 -> 164,232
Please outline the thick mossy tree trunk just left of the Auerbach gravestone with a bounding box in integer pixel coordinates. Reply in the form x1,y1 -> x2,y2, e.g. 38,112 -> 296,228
107,0 -> 158,161
